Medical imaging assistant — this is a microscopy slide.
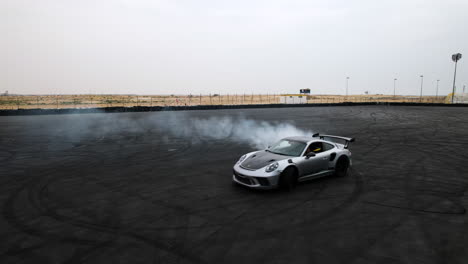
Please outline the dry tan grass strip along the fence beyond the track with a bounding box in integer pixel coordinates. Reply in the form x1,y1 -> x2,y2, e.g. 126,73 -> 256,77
0,94 -> 446,109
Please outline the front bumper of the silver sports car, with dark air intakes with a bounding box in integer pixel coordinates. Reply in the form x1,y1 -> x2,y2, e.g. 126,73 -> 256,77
232,164 -> 281,189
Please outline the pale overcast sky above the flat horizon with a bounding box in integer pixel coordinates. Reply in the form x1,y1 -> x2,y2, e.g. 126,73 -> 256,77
0,0 -> 468,95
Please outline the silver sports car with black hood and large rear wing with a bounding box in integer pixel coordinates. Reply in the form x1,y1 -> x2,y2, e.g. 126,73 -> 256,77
232,134 -> 354,189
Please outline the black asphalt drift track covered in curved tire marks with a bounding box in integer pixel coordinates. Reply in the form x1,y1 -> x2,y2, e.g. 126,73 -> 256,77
0,106 -> 468,264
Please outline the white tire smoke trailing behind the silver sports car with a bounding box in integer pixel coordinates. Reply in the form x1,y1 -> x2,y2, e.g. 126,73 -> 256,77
50,112 -> 312,149
